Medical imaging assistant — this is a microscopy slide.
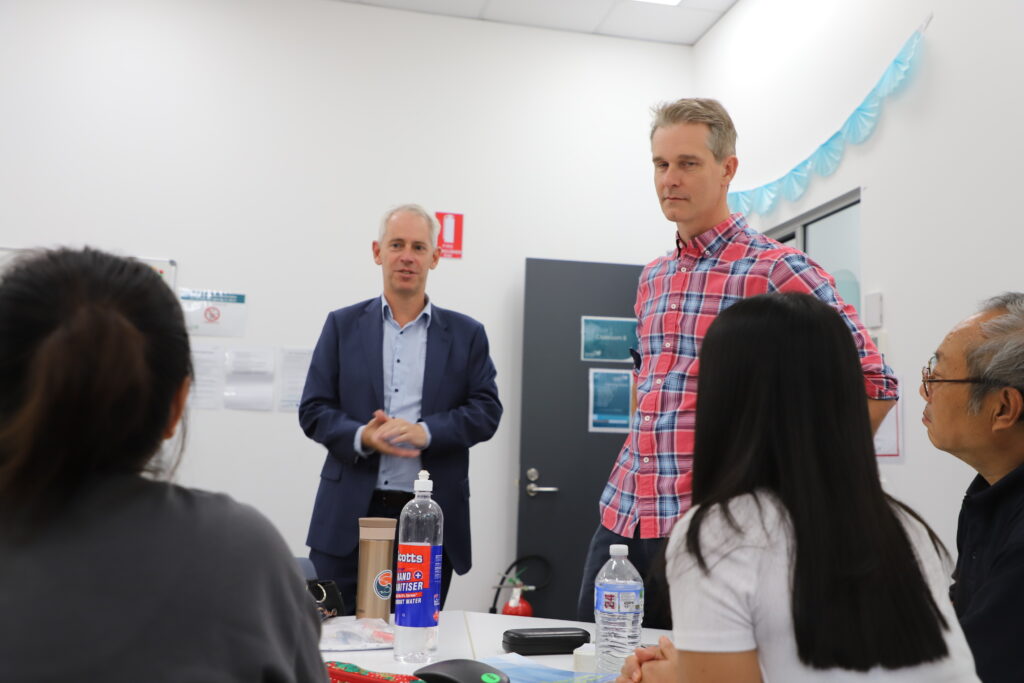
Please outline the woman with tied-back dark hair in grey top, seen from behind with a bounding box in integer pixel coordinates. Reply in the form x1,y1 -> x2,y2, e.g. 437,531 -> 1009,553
0,249 -> 327,683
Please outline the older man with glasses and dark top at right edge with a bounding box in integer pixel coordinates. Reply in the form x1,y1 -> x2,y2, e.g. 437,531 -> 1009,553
921,293 -> 1024,683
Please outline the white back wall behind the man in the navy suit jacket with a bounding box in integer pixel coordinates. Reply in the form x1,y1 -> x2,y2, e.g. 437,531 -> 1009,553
0,0 -> 692,609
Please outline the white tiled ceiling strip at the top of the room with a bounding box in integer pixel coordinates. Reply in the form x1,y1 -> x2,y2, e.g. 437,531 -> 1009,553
335,0 -> 736,45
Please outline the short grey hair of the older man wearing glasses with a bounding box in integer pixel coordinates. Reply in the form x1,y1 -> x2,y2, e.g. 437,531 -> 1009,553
967,292 -> 1024,418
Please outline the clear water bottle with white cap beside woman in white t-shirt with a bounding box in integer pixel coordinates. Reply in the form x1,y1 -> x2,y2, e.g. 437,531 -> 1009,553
594,544 -> 643,674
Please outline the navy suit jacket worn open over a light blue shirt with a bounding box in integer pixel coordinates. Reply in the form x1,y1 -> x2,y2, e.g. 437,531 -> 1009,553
299,297 -> 502,574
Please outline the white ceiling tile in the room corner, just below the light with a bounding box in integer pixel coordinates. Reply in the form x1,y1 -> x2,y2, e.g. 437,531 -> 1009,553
595,2 -> 720,45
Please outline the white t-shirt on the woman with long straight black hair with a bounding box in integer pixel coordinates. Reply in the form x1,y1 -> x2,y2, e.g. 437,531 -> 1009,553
667,494 -> 978,683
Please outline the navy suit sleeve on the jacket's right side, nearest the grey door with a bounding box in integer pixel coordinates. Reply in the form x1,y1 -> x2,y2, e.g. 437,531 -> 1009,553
421,325 -> 503,452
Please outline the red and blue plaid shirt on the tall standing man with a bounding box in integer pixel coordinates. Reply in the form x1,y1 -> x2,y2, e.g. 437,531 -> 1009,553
600,213 -> 899,539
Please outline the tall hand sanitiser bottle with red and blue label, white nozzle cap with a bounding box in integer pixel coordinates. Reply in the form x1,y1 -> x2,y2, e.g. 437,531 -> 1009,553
394,470 -> 444,663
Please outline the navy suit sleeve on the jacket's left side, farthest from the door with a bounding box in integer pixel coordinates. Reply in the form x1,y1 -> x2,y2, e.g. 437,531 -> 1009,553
299,315 -> 364,463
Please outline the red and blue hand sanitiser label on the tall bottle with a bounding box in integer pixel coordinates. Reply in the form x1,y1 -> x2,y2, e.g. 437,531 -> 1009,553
394,543 -> 441,627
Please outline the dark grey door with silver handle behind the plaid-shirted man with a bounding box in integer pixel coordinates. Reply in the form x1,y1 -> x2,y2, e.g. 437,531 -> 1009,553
516,258 -> 642,620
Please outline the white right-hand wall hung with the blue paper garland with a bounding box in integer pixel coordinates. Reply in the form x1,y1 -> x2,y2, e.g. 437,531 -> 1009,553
694,0 -> 1024,549
